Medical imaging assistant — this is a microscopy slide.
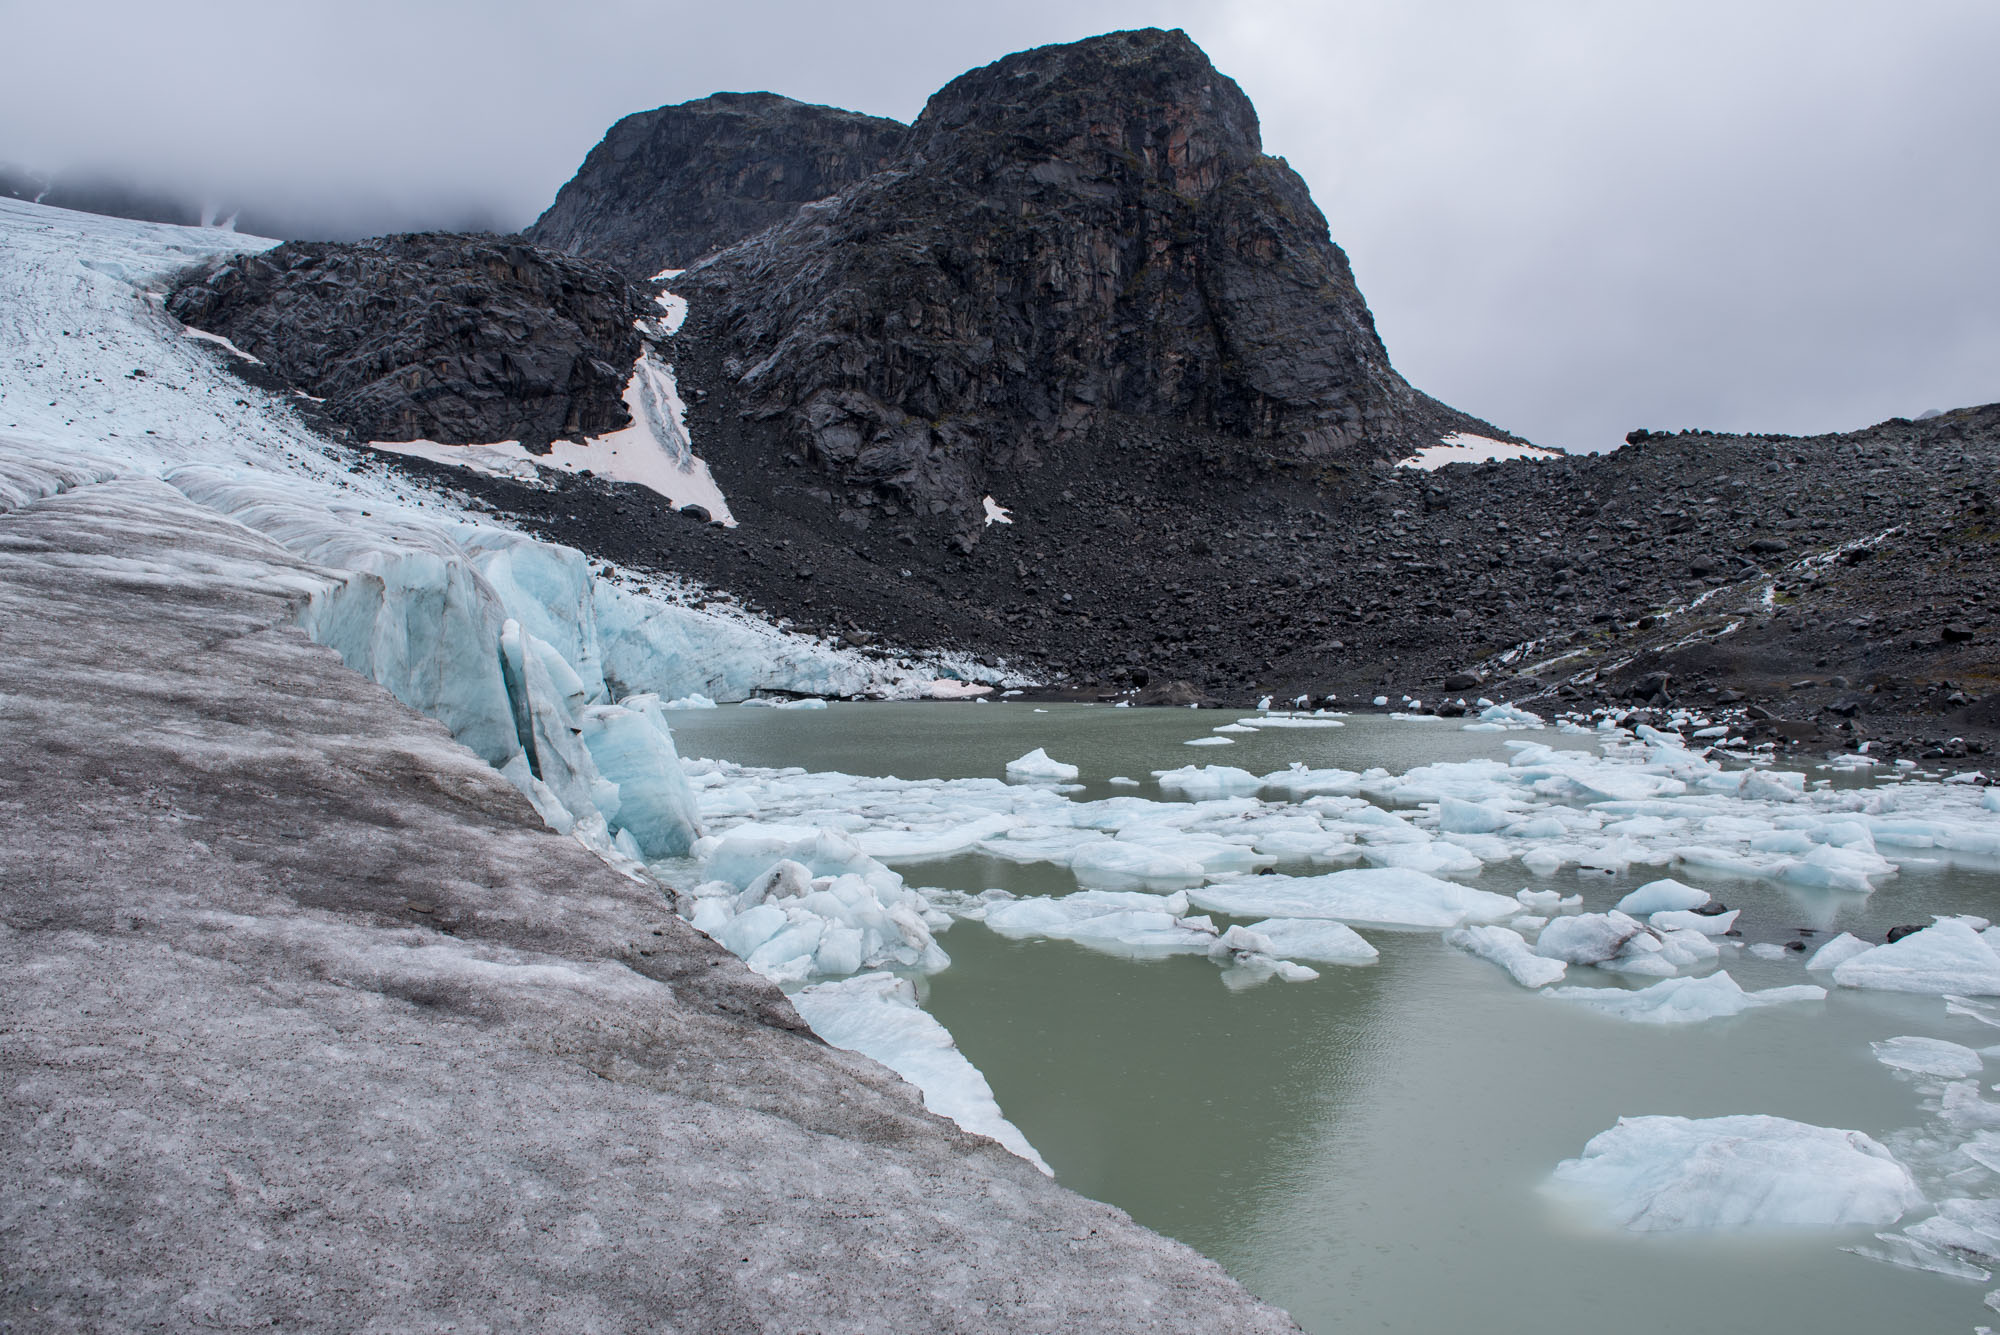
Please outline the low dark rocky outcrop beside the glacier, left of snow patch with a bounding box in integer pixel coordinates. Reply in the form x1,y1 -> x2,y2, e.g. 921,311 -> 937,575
166,232 -> 642,450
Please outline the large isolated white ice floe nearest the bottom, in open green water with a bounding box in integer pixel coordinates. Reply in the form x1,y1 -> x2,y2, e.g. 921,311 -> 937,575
1552,1115 -> 1924,1233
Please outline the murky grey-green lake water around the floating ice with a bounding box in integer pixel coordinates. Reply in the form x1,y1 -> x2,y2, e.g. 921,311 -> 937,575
672,703 -> 2000,1335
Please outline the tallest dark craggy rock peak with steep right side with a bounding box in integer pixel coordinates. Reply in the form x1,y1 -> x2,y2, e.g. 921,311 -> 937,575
678,30 -> 1496,520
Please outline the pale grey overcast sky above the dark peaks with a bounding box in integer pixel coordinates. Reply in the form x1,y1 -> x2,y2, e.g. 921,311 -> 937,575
0,0 -> 2000,450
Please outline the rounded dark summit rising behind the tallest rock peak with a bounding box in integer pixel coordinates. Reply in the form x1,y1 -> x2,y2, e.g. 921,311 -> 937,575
524,92 -> 908,278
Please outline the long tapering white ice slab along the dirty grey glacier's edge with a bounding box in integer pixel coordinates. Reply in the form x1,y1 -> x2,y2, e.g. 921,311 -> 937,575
792,973 -> 1054,1175
